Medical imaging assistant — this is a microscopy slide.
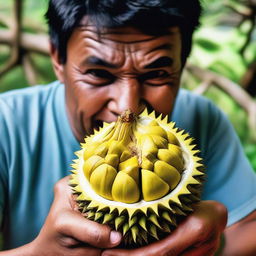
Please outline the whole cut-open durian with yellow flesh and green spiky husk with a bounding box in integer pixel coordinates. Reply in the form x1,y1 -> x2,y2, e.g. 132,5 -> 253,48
70,110 -> 204,246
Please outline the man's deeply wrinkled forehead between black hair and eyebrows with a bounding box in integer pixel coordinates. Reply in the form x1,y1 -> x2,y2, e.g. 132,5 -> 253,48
72,27 -> 180,70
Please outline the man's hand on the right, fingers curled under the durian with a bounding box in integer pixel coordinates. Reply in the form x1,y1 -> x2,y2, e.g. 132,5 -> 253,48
102,201 -> 227,256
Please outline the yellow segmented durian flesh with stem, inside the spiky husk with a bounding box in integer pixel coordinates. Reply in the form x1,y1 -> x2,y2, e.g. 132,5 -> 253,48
80,110 -> 184,203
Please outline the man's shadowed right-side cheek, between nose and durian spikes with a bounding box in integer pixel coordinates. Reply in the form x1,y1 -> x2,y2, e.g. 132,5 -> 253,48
145,85 -> 177,115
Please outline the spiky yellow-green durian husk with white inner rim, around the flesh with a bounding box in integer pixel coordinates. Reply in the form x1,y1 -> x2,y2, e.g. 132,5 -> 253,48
70,110 -> 204,247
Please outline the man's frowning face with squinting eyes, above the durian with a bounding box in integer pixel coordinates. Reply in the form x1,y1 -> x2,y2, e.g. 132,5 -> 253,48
52,22 -> 182,141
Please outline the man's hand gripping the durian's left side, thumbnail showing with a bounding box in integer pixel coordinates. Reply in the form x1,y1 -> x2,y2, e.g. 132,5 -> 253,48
32,177 -> 121,256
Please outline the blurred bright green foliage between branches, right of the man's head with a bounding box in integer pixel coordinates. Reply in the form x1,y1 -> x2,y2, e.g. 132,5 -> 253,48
183,0 -> 256,171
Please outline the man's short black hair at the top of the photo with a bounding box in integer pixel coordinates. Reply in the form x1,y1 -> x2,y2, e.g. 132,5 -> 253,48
45,0 -> 201,64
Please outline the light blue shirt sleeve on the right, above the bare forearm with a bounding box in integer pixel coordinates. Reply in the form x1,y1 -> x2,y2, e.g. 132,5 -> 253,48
203,104 -> 256,225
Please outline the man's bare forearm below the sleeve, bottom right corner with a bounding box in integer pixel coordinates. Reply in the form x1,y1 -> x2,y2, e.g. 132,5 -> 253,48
221,212 -> 256,256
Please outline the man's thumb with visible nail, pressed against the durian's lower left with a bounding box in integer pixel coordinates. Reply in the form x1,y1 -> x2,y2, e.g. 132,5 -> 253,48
55,210 -> 122,248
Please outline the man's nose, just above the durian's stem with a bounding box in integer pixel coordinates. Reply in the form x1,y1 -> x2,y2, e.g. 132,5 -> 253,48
108,77 -> 143,115
